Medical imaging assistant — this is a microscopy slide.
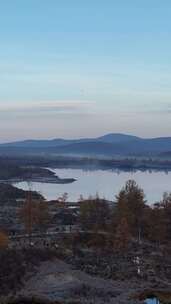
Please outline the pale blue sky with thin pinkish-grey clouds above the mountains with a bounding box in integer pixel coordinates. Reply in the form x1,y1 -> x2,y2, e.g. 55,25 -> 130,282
0,0 -> 171,142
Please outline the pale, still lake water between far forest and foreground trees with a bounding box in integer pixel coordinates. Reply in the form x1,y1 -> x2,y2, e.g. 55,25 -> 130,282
13,169 -> 171,203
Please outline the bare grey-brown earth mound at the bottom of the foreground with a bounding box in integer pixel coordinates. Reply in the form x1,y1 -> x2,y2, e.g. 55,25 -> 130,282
3,259 -> 169,304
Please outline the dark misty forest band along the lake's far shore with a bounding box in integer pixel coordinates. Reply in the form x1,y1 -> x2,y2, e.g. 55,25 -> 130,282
0,155 -> 171,171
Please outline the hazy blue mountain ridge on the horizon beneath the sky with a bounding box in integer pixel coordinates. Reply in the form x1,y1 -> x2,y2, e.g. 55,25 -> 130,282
0,133 -> 171,157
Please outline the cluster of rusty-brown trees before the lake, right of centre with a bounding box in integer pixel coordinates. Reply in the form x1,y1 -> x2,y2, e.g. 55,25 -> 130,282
80,180 -> 171,248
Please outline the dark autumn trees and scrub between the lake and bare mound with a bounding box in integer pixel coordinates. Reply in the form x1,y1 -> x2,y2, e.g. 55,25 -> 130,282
0,180 -> 171,303
